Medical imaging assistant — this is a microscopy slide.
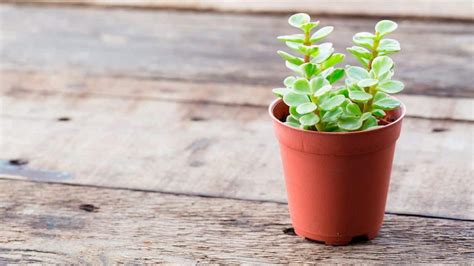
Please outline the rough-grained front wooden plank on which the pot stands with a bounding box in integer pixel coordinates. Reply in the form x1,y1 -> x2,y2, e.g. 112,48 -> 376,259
0,179 -> 474,264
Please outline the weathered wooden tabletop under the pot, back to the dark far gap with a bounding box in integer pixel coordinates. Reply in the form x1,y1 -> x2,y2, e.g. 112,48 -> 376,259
0,4 -> 474,264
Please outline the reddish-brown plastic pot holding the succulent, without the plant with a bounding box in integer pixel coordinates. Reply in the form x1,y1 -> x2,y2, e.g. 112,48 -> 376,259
269,99 -> 405,245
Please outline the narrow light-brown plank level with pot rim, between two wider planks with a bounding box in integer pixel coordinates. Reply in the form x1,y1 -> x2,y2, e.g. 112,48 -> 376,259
0,71 -> 474,122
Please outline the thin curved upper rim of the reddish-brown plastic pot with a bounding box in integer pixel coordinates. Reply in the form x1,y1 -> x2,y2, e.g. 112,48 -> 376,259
268,96 -> 406,136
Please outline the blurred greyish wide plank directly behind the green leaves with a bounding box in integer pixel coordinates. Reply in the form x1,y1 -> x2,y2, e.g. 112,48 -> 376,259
0,5 -> 474,97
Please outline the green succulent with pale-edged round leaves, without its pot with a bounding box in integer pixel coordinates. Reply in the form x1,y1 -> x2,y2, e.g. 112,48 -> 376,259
273,13 -> 404,132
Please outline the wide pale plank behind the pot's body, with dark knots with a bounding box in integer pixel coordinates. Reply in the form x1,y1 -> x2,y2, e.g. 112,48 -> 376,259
0,90 -> 474,219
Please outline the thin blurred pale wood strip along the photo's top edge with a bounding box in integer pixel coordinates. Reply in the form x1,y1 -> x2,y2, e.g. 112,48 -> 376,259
4,0 -> 473,20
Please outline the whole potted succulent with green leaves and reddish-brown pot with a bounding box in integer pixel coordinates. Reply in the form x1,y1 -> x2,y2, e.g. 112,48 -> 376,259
269,13 -> 405,245
